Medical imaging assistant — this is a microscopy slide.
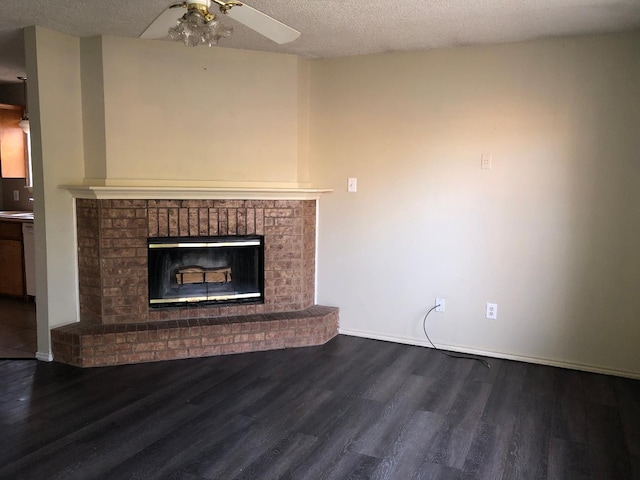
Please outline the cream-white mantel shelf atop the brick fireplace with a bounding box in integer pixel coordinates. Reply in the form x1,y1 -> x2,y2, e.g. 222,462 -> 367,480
60,185 -> 331,200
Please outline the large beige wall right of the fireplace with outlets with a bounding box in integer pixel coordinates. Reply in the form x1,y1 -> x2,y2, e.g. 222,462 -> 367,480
310,34 -> 640,375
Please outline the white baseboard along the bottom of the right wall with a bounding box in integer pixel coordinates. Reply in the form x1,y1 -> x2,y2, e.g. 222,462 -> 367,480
338,328 -> 640,379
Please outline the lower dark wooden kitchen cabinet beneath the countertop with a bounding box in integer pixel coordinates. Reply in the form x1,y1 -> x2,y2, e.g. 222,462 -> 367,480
0,222 -> 25,297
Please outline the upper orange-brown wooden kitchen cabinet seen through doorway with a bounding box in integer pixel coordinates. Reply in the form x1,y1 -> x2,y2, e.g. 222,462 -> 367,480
0,104 -> 27,178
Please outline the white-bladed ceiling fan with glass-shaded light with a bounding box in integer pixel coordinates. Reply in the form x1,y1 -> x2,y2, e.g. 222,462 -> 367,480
140,0 -> 300,46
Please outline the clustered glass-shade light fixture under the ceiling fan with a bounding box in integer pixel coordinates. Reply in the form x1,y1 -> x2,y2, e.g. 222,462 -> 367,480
169,5 -> 233,47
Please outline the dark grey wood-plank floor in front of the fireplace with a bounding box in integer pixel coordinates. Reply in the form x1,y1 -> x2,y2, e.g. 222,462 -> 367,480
0,336 -> 640,480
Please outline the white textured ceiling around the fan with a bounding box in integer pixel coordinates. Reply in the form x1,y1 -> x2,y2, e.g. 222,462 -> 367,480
0,0 -> 640,82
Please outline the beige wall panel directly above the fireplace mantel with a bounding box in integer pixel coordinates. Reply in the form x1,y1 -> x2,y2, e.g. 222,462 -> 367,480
94,37 -> 299,184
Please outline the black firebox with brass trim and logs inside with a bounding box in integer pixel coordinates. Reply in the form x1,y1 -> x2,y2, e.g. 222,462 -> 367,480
147,235 -> 264,307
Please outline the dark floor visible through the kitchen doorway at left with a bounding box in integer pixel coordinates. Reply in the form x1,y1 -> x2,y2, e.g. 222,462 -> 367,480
0,298 -> 37,359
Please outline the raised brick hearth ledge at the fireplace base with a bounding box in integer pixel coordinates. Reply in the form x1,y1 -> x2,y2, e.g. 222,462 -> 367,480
52,306 -> 338,367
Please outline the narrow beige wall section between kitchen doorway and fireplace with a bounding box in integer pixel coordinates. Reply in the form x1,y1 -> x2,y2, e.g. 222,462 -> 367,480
25,27 -> 84,358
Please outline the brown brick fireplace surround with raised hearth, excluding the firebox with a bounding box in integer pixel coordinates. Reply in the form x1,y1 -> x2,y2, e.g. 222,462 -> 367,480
52,193 -> 338,366
